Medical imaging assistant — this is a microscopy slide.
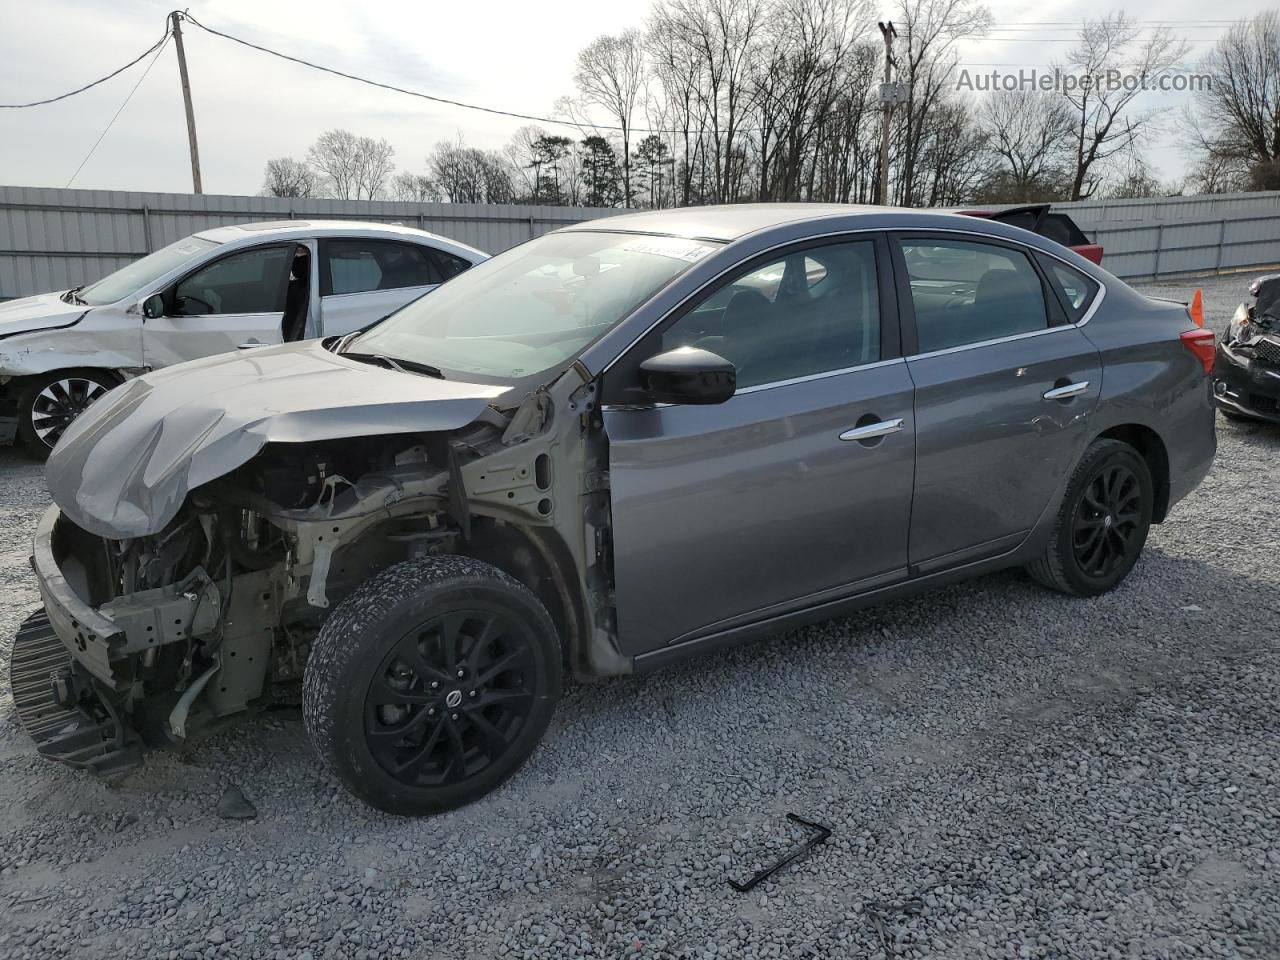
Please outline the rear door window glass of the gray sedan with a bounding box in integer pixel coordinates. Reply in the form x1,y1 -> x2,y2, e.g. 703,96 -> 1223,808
901,238 -> 1048,353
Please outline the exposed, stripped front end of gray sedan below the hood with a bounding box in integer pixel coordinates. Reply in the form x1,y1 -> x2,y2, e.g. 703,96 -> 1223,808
13,350 -> 630,773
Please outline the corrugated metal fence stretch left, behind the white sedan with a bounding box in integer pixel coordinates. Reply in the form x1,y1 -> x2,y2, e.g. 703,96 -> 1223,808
0,186 -> 622,300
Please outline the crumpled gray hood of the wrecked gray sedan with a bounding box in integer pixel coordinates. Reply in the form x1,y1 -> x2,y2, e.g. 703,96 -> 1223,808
45,340 -> 506,539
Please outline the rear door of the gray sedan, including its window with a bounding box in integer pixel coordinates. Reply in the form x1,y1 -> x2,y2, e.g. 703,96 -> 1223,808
893,233 -> 1102,573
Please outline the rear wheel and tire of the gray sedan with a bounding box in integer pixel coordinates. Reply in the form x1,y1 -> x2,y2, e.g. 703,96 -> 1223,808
1027,440 -> 1155,596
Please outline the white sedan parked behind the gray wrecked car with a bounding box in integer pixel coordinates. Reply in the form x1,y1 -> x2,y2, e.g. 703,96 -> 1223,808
0,220 -> 488,456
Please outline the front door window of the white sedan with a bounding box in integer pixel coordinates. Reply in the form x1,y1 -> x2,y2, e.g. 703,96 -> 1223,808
173,244 -> 293,316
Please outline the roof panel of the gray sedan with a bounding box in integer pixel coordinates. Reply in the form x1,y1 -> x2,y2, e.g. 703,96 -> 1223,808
563,204 -> 988,243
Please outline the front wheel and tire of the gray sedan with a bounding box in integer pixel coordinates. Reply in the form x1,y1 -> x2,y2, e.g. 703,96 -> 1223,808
302,557 -> 561,817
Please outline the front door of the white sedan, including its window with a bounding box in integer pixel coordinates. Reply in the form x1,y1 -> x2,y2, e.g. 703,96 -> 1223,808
142,243 -> 297,369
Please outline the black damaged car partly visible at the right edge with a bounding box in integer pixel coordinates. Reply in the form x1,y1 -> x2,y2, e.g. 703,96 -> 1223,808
1213,274 -> 1280,422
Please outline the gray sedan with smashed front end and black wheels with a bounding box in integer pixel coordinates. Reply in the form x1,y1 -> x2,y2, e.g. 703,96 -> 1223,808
12,205 -> 1215,814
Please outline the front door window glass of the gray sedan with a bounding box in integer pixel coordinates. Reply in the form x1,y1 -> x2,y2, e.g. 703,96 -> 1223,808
662,239 -> 881,389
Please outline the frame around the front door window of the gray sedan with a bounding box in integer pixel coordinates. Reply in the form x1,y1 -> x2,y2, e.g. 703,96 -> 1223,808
602,230 -> 904,406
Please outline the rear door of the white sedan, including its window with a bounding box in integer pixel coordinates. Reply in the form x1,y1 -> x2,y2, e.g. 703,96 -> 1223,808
320,237 -> 470,337
